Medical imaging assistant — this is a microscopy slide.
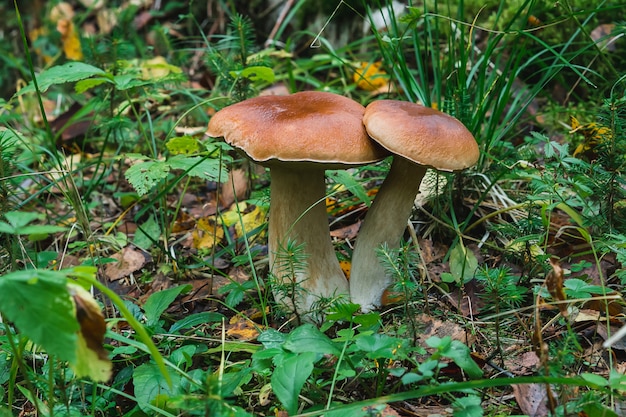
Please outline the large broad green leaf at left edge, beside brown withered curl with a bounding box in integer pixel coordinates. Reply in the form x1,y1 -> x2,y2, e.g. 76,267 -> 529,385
0,270 -> 79,362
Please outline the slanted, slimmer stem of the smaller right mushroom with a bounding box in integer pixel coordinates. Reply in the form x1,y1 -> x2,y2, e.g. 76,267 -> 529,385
350,155 -> 426,312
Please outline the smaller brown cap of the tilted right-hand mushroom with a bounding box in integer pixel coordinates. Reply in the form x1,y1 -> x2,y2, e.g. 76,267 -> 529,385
363,100 -> 479,171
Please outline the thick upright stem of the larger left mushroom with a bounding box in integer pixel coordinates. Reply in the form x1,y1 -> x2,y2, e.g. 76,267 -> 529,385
268,164 -> 349,313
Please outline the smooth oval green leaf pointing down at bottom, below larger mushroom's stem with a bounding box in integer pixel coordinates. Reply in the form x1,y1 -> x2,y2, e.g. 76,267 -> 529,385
271,352 -> 317,415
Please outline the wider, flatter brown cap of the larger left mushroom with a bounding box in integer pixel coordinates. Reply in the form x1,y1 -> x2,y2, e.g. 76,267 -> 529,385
206,91 -> 387,169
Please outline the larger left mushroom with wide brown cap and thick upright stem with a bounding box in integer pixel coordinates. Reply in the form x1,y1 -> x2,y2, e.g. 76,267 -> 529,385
207,91 -> 387,314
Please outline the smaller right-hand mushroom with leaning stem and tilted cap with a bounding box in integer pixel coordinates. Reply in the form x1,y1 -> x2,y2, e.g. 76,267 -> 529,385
350,100 -> 479,312
